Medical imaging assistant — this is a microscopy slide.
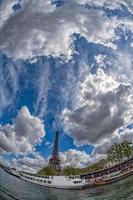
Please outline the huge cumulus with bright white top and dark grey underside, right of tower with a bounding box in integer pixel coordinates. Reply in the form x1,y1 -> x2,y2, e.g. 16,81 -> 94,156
62,69 -> 133,144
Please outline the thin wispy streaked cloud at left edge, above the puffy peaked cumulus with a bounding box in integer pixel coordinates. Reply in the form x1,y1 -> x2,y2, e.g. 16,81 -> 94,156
0,58 -> 24,117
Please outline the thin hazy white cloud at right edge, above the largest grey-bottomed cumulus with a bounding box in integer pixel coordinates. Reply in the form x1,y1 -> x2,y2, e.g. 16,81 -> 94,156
94,50 -> 133,85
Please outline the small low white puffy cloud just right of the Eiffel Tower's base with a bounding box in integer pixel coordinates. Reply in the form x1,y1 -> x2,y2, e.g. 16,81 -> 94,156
60,149 -> 90,167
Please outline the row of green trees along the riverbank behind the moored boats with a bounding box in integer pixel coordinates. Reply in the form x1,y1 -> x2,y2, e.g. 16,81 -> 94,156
38,141 -> 133,176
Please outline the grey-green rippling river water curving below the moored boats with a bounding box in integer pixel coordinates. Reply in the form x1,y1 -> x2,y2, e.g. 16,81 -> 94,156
0,168 -> 133,200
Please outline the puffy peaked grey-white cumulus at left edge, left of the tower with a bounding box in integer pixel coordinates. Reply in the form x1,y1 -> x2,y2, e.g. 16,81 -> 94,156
0,106 -> 45,153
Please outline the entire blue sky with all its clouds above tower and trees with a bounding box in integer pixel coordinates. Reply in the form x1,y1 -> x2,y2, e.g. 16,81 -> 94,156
0,0 -> 133,171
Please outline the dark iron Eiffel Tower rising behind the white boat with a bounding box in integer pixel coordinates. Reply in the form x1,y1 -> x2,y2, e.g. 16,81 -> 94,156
48,130 -> 61,171
